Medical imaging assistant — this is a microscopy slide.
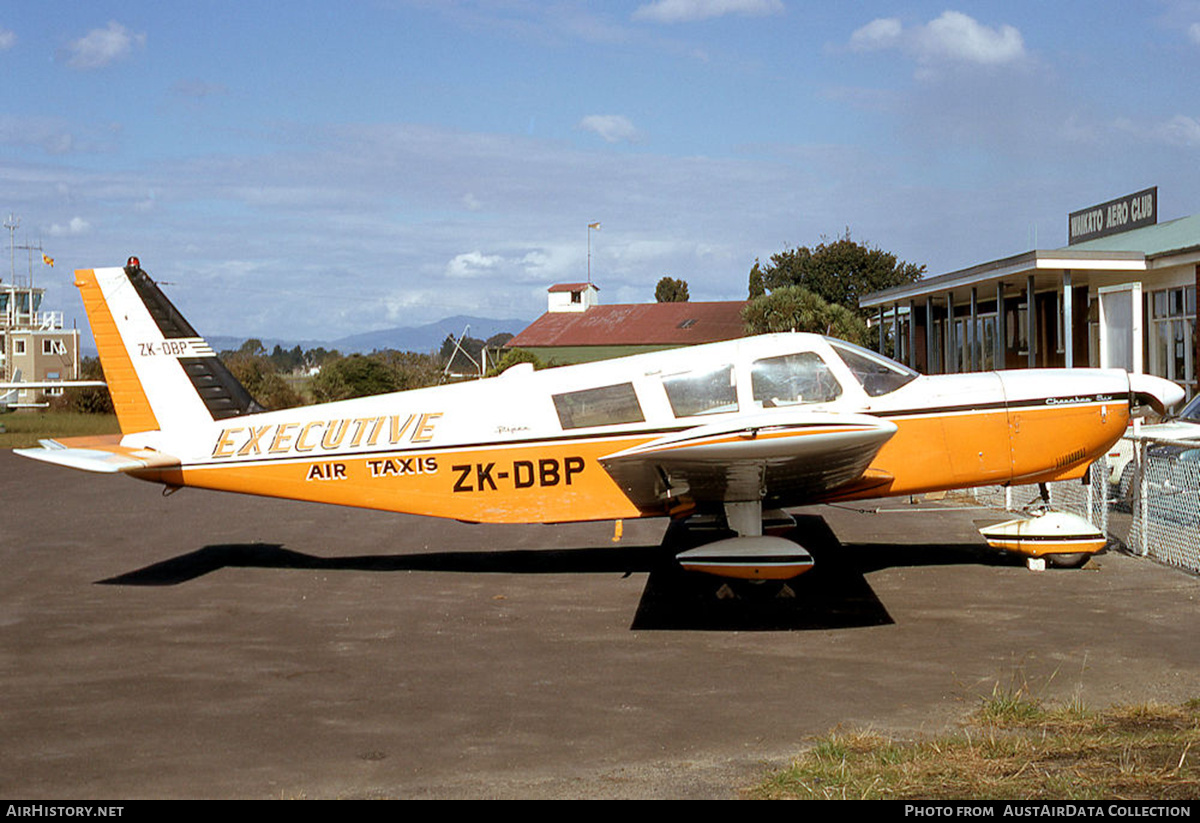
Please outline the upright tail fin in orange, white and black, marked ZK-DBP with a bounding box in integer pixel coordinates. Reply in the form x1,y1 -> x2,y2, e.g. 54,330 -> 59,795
76,265 -> 263,434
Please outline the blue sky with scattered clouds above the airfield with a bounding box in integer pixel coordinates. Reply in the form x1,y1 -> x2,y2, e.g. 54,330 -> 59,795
0,0 -> 1200,340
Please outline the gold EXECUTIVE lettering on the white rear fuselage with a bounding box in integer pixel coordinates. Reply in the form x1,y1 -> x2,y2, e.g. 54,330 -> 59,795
212,412 -> 442,458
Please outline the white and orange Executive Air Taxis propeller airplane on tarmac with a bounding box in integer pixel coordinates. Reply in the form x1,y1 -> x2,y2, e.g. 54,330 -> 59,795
17,266 -> 1183,578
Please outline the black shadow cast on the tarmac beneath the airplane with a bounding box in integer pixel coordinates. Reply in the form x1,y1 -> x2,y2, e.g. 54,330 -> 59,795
97,515 -> 1020,631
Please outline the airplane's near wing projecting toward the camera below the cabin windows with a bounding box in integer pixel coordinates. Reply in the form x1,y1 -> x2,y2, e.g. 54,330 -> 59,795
600,410 -> 896,511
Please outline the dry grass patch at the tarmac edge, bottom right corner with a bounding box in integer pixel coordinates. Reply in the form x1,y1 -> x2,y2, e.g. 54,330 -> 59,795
748,691 -> 1200,800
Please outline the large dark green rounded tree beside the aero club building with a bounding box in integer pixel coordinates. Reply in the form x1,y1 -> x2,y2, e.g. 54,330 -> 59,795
750,229 -> 925,316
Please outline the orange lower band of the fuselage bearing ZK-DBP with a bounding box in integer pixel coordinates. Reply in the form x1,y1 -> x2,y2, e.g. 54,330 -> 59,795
136,402 -> 1128,523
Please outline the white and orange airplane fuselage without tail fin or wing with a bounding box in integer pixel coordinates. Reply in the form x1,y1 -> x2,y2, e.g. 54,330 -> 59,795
117,335 -> 1130,523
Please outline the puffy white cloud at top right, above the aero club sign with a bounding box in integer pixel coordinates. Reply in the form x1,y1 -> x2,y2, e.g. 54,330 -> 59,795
850,11 -> 1026,66
